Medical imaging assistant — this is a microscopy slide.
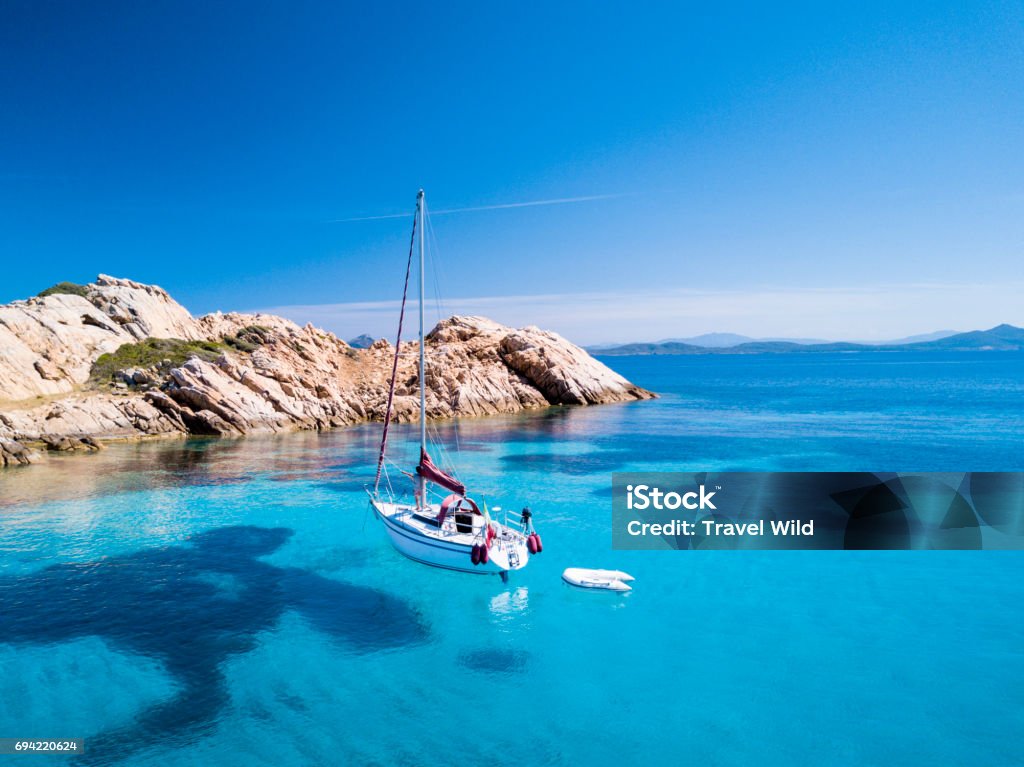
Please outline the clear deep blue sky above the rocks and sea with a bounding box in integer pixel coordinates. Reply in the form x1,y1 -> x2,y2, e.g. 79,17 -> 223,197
0,2 -> 1024,342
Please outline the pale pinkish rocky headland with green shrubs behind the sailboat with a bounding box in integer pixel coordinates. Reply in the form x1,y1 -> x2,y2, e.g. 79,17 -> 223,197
0,274 -> 654,466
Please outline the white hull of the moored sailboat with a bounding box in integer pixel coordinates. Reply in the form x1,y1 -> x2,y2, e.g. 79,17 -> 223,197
371,500 -> 529,576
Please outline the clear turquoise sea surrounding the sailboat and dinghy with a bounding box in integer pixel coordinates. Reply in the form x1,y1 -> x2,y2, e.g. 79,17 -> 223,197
0,352 -> 1024,767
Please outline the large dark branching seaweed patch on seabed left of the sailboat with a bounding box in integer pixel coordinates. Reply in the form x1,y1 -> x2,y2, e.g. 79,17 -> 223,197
0,525 -> 428,764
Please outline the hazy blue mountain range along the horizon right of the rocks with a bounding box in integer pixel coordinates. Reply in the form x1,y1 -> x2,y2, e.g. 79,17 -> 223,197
589,325 -> 1024,356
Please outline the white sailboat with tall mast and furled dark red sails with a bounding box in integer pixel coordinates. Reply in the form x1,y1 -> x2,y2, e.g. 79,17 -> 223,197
367,189 -> 543,581
